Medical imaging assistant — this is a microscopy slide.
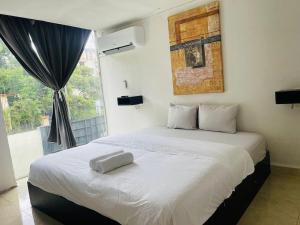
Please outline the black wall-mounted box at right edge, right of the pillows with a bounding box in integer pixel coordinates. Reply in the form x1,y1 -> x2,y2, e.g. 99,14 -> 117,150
275,89 -> 300,104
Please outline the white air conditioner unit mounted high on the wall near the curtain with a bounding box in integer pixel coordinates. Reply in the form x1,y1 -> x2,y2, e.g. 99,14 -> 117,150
97,26 -> 145,55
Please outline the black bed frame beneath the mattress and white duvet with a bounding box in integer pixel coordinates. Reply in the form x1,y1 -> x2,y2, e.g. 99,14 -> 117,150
28,152 -> 271,225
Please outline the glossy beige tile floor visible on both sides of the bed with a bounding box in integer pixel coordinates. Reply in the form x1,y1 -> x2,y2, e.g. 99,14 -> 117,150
0,167 -> 300,225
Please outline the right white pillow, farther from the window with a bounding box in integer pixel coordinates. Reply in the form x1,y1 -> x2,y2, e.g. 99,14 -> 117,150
198,104 -> 238,134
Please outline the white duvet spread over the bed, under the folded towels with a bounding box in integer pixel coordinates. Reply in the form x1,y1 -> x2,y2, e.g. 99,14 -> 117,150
29,133 -> 254,225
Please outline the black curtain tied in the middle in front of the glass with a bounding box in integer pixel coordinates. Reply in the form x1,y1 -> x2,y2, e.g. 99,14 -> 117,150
0,15 -> 91,148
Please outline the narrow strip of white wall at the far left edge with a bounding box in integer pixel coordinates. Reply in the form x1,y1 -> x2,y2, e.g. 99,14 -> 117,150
0,104 -> 16,192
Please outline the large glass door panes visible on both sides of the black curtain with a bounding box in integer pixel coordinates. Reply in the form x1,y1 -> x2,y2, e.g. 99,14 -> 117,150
0,33 -> 106,178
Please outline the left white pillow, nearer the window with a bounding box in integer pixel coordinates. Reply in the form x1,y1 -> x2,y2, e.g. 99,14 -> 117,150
168,104 -> 197,129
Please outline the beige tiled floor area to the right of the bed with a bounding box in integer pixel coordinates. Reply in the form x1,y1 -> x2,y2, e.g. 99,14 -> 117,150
239,168 -> 300,225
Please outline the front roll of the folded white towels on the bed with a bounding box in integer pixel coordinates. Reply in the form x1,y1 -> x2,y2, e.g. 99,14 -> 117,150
95,152 -> 133,173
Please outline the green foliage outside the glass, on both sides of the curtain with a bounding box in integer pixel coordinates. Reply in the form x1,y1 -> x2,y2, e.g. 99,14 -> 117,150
0,42 -> 100,132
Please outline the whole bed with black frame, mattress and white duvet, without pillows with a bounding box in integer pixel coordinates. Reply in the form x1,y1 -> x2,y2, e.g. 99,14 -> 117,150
28,127 -> 270,225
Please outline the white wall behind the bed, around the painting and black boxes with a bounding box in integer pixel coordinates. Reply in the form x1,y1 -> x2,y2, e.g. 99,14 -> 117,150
100,0 -> 300,167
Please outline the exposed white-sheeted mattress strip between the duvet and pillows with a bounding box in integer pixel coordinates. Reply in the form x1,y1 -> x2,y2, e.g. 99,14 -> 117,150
139,127 -> 267,165
